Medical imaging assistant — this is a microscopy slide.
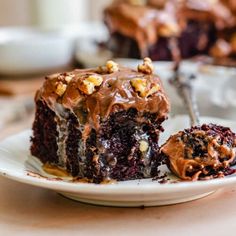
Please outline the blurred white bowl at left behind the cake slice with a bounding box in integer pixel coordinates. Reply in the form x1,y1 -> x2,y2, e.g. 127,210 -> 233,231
0,27 -> 74,76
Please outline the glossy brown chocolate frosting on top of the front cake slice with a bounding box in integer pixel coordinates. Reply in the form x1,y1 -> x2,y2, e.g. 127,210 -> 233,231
35,60 -> 169,132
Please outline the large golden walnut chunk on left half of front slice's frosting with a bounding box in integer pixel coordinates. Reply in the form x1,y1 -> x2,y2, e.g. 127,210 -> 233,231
78,74 -> 103,95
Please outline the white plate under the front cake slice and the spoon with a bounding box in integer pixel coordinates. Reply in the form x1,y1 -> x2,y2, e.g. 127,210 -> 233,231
0,116 -> 236,207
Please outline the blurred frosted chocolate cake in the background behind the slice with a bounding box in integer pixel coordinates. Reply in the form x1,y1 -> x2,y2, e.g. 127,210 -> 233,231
104,0 -> 236,62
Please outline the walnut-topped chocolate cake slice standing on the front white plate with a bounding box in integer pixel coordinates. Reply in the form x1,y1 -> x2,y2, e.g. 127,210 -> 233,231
31,58 -> 169,183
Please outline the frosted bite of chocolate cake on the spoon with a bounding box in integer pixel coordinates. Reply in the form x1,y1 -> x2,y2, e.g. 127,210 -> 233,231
160,124 -> 236,180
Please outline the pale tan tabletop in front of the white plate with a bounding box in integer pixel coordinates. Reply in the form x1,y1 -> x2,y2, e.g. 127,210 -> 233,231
0,174 -> 236,236
